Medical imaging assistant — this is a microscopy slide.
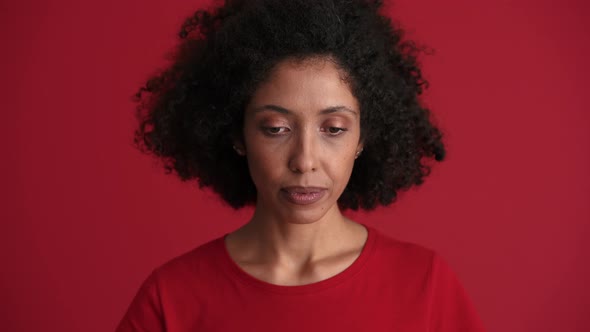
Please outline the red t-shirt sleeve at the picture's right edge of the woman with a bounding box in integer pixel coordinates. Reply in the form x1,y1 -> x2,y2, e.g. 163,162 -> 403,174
428,253 -> 485,332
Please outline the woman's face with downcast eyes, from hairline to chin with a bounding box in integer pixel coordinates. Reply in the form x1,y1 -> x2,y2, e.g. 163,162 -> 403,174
236,59 -> 362,223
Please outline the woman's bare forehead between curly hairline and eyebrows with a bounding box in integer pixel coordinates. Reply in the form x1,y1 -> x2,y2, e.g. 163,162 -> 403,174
247,58 -> 359,113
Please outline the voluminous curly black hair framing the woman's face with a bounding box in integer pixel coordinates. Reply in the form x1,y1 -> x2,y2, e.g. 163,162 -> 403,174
134,0 -> 445,210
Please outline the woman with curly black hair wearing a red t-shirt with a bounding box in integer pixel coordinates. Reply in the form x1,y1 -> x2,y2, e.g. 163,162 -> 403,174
117,0 -> 483,332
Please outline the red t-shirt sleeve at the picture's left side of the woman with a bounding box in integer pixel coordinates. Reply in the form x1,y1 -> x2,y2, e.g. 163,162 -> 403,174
115,269 -> 166,332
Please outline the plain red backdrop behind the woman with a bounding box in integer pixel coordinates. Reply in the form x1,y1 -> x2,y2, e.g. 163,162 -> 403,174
0,0 -> 590,332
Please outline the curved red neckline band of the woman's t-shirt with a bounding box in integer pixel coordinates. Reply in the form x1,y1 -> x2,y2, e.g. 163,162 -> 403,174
217,223 -> 377,295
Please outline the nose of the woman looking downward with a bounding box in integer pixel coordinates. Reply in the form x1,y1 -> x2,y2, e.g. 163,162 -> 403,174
289,130 -> 321,173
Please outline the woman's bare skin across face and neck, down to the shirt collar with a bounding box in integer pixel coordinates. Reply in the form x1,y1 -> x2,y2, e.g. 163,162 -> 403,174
226,58 -> 367,285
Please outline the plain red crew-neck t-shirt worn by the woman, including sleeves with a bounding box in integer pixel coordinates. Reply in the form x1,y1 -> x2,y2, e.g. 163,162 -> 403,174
117,225 -> 484,332
